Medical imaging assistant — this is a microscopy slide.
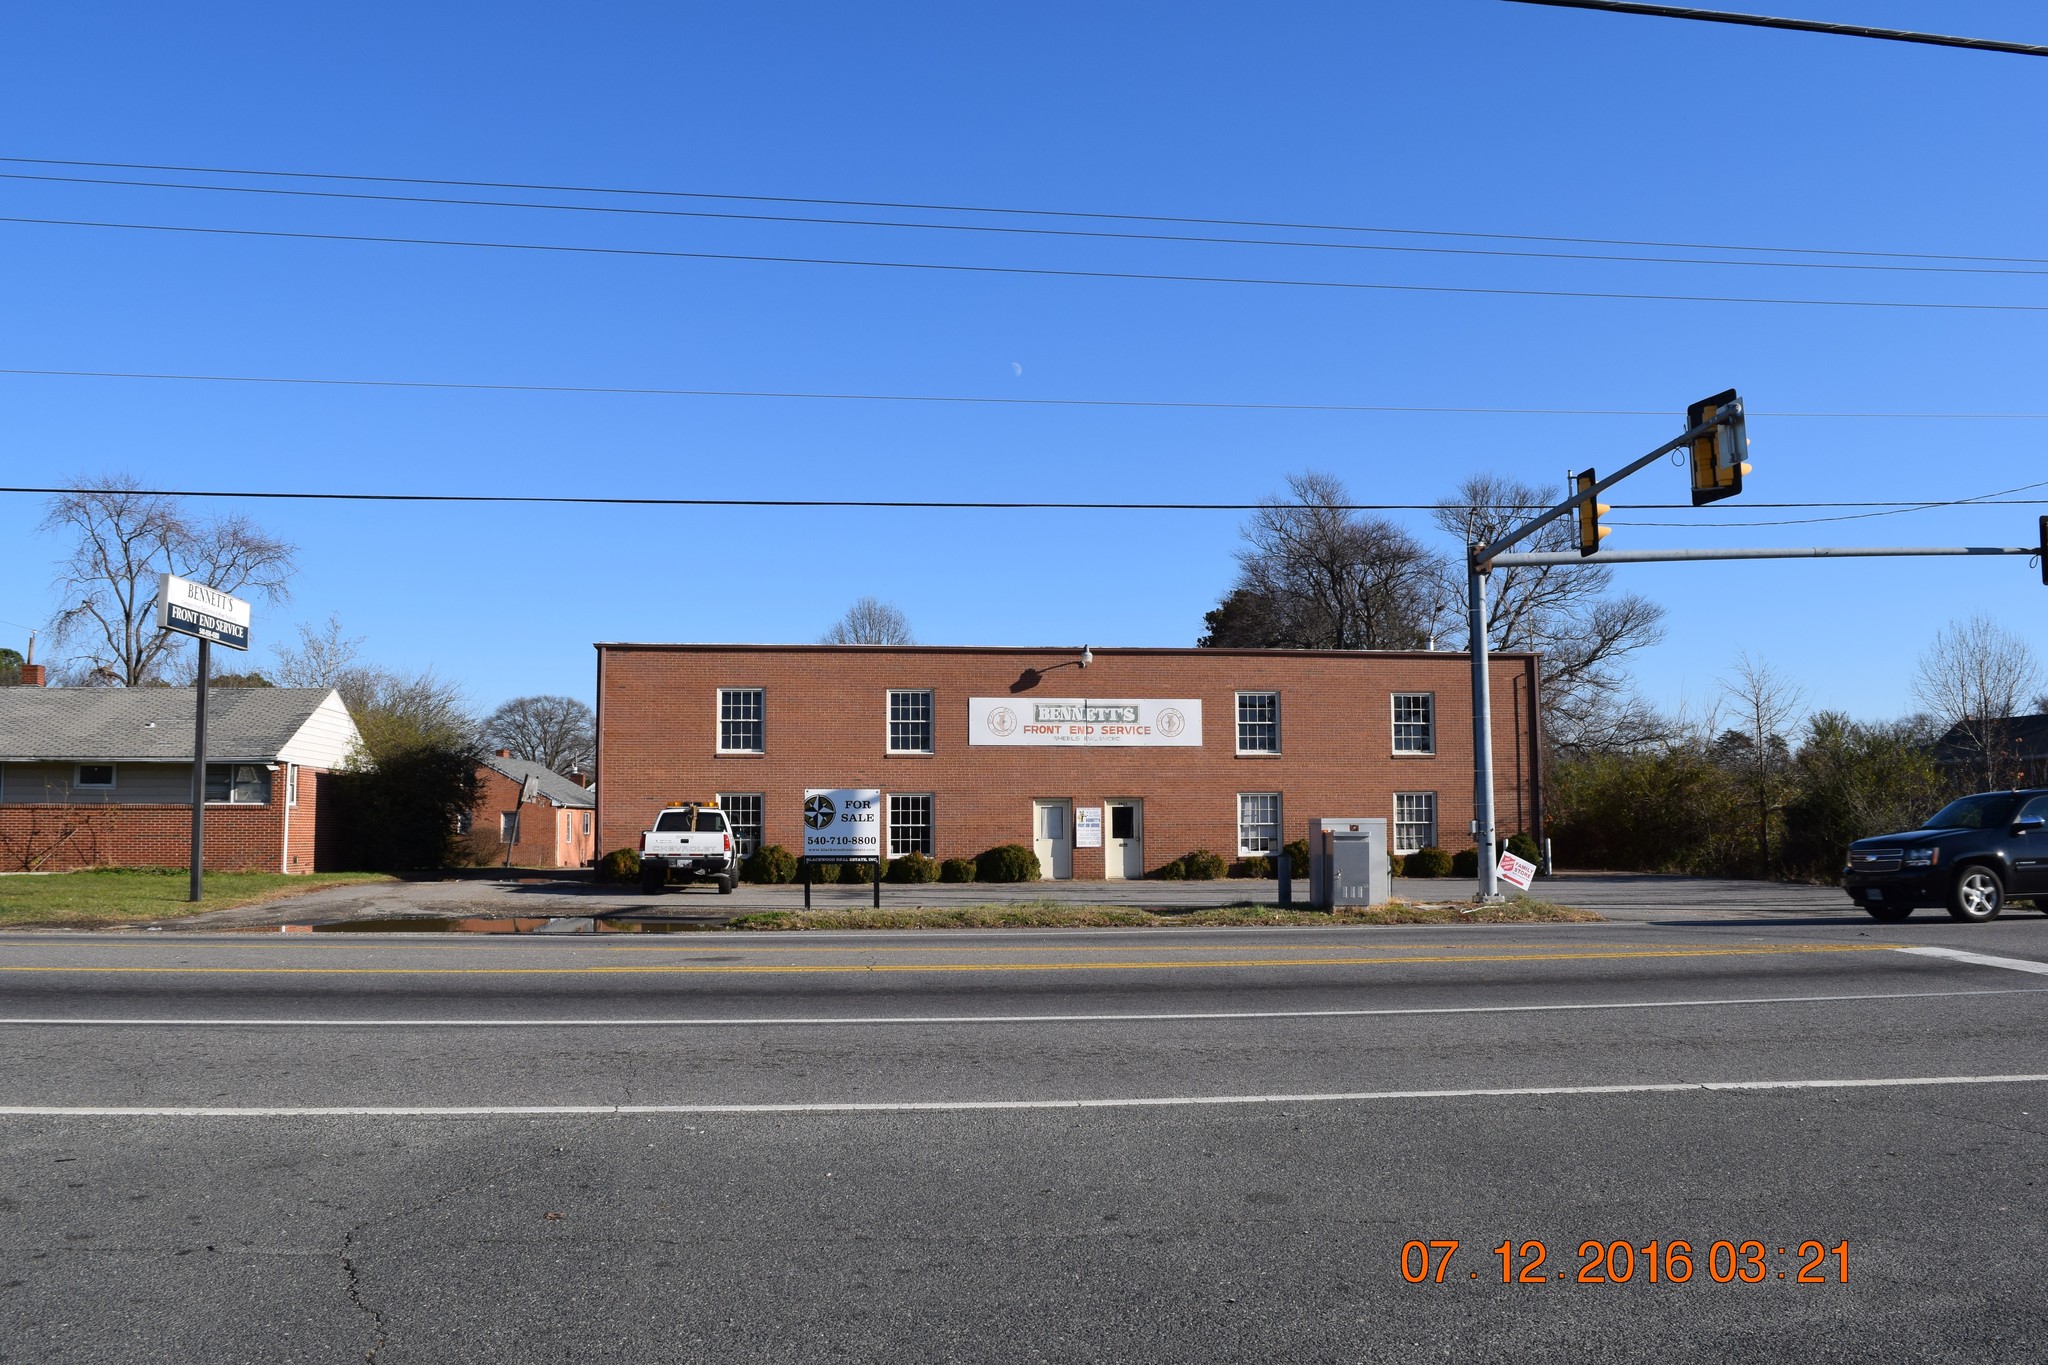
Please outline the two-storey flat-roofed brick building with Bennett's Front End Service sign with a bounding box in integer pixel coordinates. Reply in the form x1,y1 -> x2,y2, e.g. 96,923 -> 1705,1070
596,645 -> 1542,880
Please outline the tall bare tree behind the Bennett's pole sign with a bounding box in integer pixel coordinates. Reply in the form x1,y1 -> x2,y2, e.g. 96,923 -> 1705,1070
41,475 -> 295,688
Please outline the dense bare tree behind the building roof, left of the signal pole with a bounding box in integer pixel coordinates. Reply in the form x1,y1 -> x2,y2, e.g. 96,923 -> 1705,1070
1200,471 -> 1442,649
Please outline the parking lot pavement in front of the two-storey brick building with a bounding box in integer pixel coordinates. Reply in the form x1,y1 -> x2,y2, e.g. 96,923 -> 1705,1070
132,870 -> 1916,929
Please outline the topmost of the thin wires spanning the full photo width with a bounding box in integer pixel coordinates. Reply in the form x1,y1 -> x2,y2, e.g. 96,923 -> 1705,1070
0,156 -> 2048,266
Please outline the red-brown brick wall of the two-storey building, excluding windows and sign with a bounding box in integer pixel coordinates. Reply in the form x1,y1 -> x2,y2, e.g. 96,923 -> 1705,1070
598,645 -> 1538,878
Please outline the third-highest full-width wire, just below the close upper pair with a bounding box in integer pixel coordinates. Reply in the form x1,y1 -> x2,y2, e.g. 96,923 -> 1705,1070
0,217 -> 2048,313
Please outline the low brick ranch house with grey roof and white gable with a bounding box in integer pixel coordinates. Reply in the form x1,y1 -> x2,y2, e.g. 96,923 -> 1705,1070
0,684 -> 358,872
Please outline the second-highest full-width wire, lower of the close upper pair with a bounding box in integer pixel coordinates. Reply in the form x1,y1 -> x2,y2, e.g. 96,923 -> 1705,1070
0,172 -> 2048,276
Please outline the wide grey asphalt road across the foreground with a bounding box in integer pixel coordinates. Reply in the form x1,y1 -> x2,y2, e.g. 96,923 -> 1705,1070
0,911 -> 2048,1361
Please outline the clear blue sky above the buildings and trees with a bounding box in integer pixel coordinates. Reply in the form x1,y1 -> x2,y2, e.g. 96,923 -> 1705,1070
0,0 -> 2048,716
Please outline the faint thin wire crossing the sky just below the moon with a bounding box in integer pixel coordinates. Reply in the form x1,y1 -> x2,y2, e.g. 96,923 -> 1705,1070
0,366 -> 2048,422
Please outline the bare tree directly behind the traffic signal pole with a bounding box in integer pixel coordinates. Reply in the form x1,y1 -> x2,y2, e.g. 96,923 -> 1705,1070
1432,475 -> 1665,753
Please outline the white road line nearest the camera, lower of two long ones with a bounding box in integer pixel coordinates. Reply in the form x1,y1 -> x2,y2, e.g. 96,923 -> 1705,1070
0,1074 -> 2048,1119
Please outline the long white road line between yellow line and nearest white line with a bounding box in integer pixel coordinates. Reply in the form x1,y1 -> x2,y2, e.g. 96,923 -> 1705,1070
0,986 -> 2048,1029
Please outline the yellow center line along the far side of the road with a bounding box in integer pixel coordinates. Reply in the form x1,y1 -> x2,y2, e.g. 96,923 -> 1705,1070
0,943 -> 1898,976
